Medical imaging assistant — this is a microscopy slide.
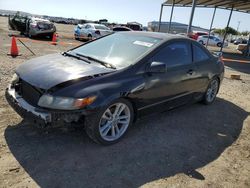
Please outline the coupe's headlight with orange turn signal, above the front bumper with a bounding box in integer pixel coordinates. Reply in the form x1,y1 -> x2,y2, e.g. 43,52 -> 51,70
38,94 -> 96,110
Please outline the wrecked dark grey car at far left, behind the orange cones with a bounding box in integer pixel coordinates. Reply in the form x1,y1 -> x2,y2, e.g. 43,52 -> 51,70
9,14 -> 56,38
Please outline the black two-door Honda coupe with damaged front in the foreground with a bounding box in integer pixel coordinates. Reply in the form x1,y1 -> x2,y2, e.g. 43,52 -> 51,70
5,32 -> 224,144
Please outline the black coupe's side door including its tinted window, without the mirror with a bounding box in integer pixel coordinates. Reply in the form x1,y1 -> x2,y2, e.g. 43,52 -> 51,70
137,41 -> 196,110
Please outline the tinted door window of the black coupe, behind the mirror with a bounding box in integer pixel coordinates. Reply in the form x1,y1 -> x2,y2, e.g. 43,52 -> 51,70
153,42 -> 192,67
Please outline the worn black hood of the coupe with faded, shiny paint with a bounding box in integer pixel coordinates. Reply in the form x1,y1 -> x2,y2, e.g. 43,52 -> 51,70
16,54 -> 114,90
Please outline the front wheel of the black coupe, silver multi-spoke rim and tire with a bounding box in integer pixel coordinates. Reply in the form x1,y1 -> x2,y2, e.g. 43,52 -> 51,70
85,99 -> 134,145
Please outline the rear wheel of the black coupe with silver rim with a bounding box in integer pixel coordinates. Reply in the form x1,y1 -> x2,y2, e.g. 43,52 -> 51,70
203,78 -> 219,105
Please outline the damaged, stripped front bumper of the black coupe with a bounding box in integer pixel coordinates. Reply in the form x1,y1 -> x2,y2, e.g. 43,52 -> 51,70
5,87 -> 89,127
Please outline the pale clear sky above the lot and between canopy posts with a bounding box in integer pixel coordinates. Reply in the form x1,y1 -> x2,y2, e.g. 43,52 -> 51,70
0,0 -> 250,31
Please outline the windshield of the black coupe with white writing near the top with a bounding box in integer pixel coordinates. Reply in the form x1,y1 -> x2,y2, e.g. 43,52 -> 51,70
72,33 -> 161,68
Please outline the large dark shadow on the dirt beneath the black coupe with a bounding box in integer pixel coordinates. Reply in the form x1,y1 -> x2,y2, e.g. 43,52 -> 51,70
5,98 -> 249,187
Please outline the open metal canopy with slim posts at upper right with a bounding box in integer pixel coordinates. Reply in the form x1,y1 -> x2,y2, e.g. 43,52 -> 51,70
158,0 -> 250,55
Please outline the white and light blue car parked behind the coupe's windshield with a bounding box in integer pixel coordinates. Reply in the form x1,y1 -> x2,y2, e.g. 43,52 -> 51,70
75,23 -> 112,40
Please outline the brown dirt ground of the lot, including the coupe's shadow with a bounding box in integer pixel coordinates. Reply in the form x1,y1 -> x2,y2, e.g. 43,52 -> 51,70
0,17 -> 250,188
